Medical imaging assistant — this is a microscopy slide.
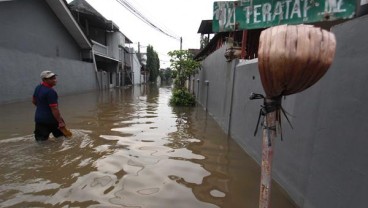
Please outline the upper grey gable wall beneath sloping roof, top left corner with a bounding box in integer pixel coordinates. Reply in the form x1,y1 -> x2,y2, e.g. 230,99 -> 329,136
0,0 -> 81,60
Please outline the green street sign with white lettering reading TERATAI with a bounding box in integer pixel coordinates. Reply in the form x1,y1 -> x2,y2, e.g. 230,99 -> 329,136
212,0 -> 357,32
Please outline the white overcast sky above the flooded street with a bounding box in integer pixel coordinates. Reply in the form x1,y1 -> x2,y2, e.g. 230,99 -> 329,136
68,0 -> 215,68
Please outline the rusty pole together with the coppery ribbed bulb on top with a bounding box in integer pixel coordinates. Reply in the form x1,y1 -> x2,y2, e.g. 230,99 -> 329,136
250,25 -> 336,208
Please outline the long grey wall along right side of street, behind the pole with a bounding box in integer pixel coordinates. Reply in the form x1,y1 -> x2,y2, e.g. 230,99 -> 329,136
195,16 -> 368,208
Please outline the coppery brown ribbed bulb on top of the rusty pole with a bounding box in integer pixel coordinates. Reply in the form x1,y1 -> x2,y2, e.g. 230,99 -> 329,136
258,25 -> 336,99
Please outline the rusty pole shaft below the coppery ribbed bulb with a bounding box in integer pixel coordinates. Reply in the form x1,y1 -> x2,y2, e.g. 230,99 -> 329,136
259,99 -> 277,208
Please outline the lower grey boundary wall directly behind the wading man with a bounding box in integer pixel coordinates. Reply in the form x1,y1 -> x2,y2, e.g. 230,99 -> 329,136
0,48 -> 98,104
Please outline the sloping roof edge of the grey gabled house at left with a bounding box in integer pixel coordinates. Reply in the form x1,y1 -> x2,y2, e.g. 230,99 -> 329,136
45,0 -> 92,49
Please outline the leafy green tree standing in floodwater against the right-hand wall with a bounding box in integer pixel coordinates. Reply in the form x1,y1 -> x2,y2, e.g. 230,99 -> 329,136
168,50 -> 201,106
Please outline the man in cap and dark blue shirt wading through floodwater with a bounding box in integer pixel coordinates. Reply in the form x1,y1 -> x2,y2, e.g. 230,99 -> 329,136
32,71 -> 65,141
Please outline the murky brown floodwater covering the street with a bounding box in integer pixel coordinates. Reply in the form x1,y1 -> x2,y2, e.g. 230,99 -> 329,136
0,86 -> 294,208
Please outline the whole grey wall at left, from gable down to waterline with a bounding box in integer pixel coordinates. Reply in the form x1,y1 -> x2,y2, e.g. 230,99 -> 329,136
0,0 -> 98,104
